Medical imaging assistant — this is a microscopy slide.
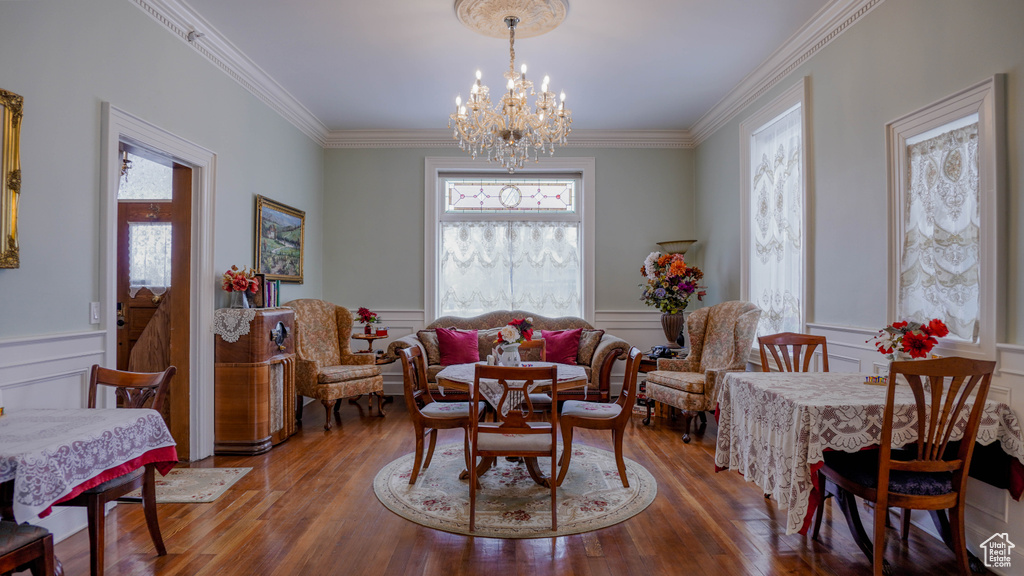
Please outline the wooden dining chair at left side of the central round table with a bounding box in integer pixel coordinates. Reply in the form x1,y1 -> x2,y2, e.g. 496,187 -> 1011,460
398,346 -> 483,484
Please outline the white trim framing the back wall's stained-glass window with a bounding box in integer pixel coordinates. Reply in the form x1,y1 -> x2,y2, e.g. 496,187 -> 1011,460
423,156 -> 596,324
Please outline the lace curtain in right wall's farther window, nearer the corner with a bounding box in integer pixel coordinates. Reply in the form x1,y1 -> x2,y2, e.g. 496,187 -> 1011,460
750,107 -> 804,335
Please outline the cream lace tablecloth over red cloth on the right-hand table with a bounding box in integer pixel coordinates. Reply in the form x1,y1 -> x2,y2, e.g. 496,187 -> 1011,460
715,372 -> 1024,534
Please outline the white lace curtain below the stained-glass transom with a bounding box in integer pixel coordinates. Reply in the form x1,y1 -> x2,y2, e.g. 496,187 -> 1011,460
438,221 -> 583,317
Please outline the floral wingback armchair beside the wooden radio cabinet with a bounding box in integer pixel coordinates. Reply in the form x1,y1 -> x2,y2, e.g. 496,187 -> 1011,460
284,298 -> 384,430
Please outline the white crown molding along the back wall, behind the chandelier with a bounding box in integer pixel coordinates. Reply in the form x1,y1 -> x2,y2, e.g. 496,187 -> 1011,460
324,130 -> 694,149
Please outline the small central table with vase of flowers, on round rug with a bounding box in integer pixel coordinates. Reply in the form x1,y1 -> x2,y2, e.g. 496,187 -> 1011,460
436,362 -> 588,488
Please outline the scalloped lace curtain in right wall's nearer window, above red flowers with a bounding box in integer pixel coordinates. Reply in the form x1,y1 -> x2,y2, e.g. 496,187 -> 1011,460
899,123 -> 981,341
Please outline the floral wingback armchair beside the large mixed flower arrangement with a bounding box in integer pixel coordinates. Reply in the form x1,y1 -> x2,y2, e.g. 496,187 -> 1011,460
644,300 -> 761,443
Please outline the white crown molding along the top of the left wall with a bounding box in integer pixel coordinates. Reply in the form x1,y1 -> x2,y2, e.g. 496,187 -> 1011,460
131,0 -> 328,146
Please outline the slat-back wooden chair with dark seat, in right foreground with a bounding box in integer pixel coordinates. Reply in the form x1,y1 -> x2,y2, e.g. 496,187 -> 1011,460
821,357 -> 995,576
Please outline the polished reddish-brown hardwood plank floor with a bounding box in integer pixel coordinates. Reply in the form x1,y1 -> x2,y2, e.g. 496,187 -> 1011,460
55,399 -> 955,576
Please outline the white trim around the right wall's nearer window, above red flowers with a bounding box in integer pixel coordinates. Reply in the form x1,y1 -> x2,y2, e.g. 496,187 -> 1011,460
886,74 -> 1009,358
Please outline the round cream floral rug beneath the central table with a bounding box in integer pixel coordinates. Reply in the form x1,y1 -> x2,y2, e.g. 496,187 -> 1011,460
374,442 -> 657,538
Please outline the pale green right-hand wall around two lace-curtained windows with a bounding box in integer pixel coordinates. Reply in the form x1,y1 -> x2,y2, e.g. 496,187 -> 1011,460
695,0 -> 1024,343
